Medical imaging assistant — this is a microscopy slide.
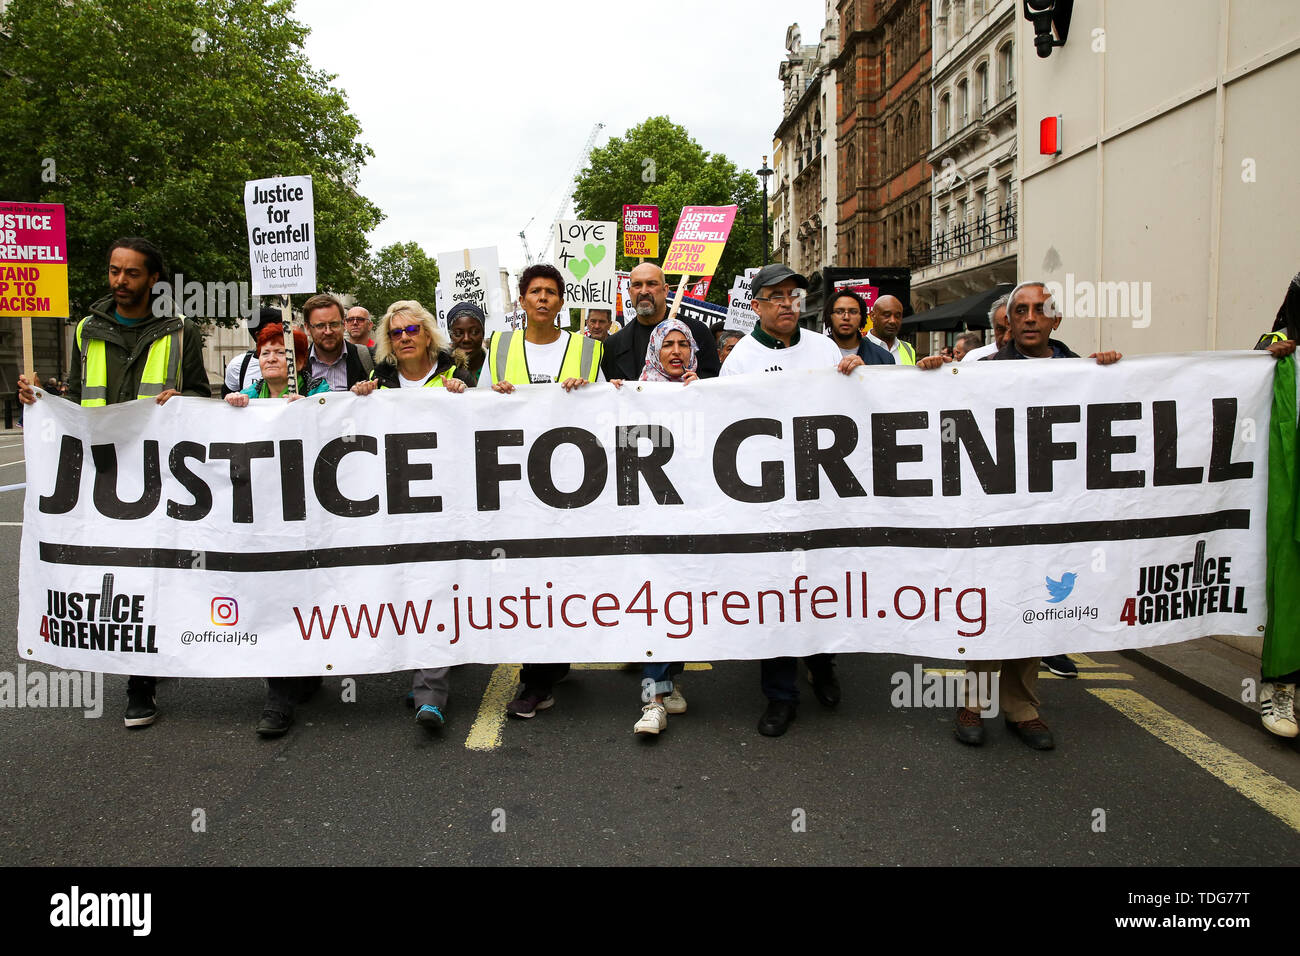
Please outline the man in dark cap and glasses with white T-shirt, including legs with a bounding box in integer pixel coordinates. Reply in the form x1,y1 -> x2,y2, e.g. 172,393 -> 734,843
722,264 -> 866,737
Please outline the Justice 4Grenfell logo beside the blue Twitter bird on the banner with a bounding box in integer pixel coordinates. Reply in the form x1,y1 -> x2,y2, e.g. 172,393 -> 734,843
1119,541 -> 1249,627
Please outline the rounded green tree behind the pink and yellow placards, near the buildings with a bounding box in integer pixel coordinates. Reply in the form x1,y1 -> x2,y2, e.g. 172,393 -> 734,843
573,116 -> 763,304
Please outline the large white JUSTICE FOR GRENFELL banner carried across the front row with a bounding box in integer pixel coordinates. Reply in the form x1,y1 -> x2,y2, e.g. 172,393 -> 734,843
18,352 -> 1274,676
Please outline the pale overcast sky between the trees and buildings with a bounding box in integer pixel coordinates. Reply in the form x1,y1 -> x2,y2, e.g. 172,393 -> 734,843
294,0 -> 824,282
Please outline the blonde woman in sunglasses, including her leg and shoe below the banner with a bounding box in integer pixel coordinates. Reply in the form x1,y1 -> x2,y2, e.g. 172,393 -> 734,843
352,299 -> 469,730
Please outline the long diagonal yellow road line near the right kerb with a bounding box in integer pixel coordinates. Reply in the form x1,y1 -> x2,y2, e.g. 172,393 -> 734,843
1088,687 -> 1300,832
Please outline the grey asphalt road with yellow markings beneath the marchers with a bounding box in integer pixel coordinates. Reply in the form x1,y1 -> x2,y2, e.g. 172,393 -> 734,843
0,432 -> 1300,866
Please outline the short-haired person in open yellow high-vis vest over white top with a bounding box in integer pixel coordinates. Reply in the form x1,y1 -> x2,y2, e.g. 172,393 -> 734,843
478,263 -> 605,718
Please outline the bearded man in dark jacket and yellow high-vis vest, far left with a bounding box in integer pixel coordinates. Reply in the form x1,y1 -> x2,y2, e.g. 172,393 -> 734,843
18,237 -> 212,727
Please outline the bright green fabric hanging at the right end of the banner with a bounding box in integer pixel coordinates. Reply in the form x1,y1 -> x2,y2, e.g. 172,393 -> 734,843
1260,356 -> 1300,680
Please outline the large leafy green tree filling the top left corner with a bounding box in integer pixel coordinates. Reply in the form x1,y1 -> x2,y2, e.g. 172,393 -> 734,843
0,0 -> 384,324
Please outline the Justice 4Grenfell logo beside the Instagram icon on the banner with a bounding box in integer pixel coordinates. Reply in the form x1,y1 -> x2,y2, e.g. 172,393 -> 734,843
40,574 -> 157,654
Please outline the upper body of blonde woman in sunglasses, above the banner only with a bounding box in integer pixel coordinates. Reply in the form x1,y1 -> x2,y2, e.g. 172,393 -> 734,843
352,299 -> 471,395
